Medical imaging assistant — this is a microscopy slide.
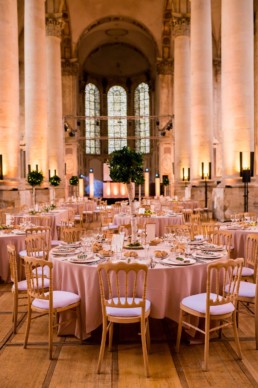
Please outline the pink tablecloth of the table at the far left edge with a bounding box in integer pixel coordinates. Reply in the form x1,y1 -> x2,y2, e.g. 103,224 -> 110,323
0,234 -> 25,282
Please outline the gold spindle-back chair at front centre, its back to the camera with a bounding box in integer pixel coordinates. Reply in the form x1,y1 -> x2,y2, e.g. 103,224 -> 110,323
97,262 -> 151,377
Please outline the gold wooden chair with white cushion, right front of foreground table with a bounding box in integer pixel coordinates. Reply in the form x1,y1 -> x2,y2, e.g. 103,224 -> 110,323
176,259 -> 244,371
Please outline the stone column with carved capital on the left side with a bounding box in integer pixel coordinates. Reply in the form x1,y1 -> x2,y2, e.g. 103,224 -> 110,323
46,18 -> 64,180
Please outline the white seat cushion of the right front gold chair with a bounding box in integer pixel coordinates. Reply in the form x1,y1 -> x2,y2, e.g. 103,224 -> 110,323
181,292 -> 235,315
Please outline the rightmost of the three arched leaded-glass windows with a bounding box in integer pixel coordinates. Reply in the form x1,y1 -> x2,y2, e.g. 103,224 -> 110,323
134,82 -> 150,154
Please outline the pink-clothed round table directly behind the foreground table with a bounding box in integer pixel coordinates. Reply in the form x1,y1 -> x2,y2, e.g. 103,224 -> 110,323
114,214 -> 184,237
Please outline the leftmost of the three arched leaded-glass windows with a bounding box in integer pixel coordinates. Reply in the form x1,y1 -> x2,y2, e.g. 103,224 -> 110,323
85,83 -> 100,155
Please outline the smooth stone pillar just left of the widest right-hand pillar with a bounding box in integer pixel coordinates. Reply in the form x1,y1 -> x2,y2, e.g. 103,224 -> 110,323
191,0 -> 213,180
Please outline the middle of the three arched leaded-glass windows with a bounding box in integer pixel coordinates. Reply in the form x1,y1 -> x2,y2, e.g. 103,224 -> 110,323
107,86 -> 127,154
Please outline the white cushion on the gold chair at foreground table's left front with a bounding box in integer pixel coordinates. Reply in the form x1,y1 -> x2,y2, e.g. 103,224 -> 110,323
32,291 -> 81,310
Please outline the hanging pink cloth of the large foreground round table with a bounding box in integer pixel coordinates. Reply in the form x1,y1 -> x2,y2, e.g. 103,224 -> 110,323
50,247 -> 214,339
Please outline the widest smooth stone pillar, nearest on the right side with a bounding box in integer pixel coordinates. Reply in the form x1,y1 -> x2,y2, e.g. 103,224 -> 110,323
221,0 -> 254,180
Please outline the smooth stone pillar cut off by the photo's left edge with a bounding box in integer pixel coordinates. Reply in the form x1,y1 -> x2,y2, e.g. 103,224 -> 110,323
0,0 -> 20,180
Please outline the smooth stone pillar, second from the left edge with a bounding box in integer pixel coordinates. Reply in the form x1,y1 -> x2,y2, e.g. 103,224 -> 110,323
24,0 -> 48,179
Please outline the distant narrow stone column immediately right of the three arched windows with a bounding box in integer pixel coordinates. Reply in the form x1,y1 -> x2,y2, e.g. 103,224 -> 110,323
158,61 -> 174,194
